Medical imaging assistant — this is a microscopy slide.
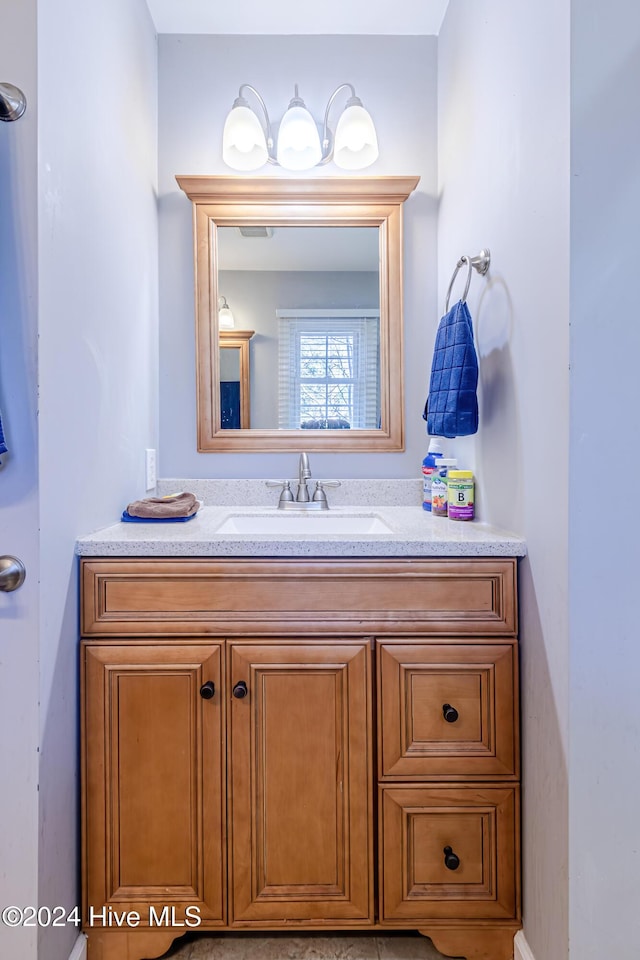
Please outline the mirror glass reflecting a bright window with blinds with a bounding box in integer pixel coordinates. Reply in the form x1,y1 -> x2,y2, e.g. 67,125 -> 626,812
216,224 -> 380,430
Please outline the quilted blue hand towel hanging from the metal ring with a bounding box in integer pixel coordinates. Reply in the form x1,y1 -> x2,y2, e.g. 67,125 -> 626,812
422,300 -> 478,437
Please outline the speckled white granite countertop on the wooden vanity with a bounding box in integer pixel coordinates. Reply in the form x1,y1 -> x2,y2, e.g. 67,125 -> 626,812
76,498 -> 526,557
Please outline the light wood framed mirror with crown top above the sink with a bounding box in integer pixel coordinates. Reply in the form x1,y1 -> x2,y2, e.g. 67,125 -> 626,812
176,176 -> 419,452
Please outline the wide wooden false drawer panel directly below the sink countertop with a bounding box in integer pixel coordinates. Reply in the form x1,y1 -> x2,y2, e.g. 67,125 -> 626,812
82,558 -> 516,643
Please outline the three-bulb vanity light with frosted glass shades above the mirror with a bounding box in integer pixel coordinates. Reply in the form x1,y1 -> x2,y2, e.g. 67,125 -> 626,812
222,83 -> 378,172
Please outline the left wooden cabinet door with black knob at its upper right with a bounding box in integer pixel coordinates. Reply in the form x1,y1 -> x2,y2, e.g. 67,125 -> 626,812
82,641 -> 225,926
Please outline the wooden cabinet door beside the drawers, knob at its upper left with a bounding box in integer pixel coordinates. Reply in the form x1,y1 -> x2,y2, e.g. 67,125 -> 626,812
229,642 -> 373,925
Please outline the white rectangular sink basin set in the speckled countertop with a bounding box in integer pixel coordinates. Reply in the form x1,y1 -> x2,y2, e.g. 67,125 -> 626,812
216,510 -> 392,537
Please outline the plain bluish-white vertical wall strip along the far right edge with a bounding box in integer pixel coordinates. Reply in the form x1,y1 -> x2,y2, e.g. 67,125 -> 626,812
569,0 -> 640,960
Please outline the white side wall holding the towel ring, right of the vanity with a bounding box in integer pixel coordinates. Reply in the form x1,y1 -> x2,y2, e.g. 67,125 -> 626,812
438,0 -> 568,960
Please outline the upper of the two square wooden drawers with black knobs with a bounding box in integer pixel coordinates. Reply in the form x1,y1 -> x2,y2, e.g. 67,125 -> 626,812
377,641 -> 518,780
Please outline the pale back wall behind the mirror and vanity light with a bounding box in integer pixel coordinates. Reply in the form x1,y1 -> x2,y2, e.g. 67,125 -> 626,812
159,35 -> 437,477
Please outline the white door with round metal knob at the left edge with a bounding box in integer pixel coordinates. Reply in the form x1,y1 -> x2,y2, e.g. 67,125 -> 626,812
0,0 -> 39,960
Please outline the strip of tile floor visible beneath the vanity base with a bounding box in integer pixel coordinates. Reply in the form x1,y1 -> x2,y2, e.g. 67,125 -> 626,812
156,933 -> 456,960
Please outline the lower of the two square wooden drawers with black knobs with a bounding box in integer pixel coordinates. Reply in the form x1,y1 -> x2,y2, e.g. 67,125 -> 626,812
380,784 -> 519,923
